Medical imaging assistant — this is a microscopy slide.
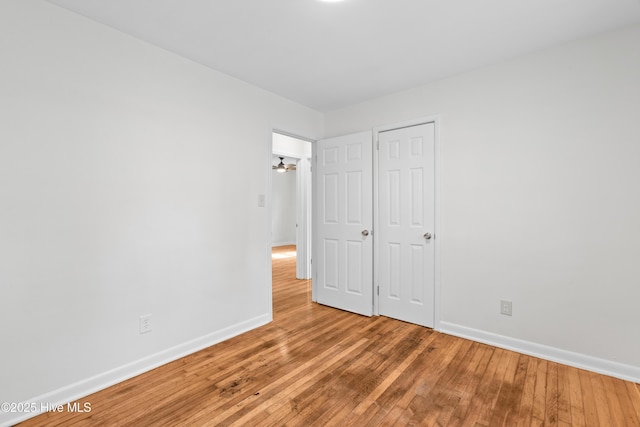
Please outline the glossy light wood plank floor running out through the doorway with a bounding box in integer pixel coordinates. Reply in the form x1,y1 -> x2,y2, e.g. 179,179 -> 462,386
24,247 -> 640,426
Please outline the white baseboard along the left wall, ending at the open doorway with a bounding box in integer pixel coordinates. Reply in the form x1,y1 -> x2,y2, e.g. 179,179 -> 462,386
0,314 -> 272,427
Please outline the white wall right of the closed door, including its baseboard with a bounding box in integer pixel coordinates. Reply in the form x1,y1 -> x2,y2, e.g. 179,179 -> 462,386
325,26 -> 640,381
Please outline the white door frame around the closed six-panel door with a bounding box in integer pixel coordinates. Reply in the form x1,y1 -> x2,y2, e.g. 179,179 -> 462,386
373,115 -> 442,331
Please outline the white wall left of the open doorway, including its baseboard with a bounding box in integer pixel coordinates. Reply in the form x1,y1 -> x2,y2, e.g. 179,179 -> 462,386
0,0 -> 323,425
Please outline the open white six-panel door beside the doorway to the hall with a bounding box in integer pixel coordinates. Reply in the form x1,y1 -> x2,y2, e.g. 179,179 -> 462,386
313,132 -> 373,316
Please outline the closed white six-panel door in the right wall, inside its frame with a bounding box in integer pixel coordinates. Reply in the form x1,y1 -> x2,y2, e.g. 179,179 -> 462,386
376,123 -> 435,327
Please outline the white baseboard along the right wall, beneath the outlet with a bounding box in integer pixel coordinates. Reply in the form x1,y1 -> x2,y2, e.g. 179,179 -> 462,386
439,321 -> 640,383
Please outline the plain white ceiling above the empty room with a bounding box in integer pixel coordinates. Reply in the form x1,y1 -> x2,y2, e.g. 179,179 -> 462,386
49,0 -> 640,112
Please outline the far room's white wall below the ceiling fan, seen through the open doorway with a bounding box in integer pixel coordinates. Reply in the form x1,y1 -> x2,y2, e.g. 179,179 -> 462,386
271,171 -> 296,246
